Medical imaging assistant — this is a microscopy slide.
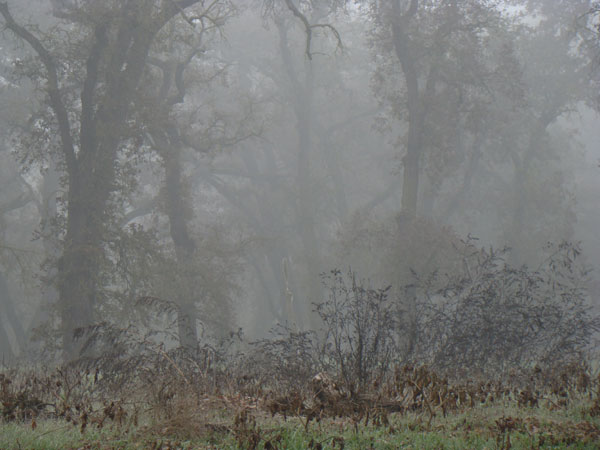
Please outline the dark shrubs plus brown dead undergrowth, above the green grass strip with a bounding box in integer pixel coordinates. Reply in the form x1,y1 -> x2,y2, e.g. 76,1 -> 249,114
0,243 -> 600,429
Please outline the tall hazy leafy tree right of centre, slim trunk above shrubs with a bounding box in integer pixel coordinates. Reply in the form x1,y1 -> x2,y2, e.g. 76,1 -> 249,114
367,0 -> 510,218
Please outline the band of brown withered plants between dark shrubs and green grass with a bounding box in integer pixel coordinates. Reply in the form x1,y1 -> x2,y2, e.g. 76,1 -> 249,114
0,360 -> 600,449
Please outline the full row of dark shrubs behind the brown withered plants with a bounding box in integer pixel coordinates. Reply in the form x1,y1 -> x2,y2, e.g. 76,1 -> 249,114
19,242 -> 600,388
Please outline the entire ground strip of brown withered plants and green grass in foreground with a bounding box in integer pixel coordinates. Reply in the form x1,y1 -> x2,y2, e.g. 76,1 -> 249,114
0,362 -> 600,450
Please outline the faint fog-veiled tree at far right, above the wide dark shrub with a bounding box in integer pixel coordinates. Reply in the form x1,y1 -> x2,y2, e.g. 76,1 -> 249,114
437,0 -> 594,265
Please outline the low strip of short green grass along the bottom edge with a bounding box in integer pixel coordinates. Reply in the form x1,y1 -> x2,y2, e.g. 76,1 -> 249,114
0,405 -> 600,450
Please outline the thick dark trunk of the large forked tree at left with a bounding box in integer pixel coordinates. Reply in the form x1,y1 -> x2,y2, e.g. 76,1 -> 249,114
58,4 -> 153,359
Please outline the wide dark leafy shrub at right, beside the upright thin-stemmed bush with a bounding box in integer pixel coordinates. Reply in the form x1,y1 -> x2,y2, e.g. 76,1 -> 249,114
414,243 -> 600,373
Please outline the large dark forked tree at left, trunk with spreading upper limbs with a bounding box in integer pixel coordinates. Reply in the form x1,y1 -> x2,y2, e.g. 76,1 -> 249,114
0,0 -> 224,358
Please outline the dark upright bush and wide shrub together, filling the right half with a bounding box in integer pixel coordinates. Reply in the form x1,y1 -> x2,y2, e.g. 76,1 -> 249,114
253,243 -> 600,393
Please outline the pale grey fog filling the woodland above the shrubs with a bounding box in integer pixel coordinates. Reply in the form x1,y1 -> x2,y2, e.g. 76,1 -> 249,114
0,0 -> 600,364
